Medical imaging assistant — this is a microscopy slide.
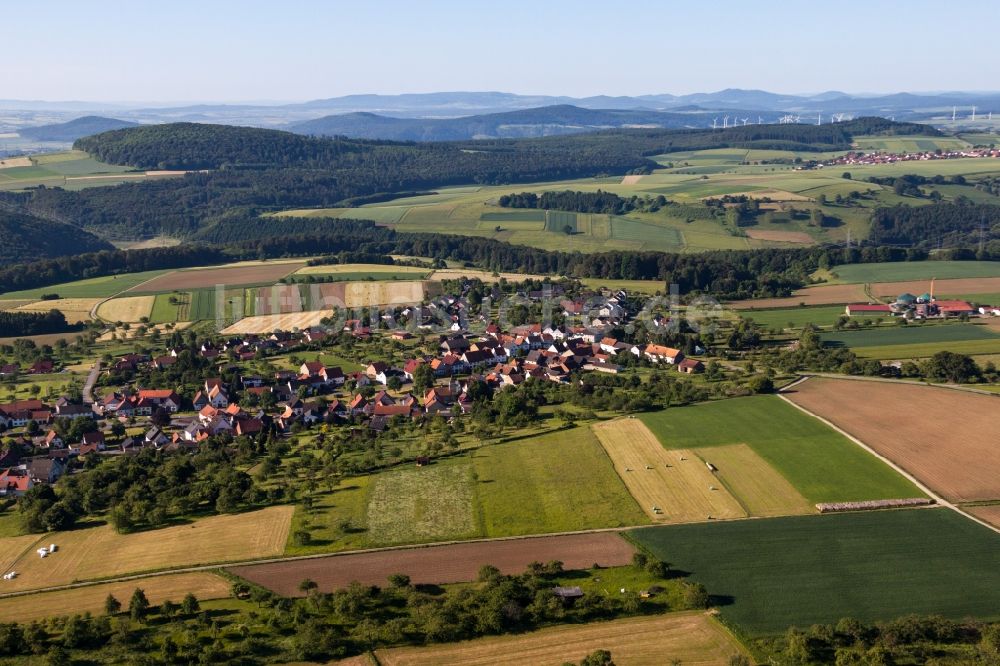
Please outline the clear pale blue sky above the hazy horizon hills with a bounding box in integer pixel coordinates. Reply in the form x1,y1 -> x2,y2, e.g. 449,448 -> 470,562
0,0 -> 1000,101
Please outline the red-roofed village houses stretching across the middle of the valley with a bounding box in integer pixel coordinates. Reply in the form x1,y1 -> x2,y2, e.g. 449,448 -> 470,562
0,282 -> 705,496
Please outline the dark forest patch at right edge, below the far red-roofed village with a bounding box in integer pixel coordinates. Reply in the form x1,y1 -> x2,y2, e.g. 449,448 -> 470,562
870,203 -> 1000,248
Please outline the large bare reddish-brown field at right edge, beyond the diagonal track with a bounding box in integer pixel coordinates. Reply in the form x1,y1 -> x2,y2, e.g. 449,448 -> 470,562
786,378 -> 1000,502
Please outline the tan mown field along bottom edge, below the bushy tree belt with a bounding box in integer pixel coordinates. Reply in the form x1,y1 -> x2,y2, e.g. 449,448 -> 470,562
375,613 -> 743,666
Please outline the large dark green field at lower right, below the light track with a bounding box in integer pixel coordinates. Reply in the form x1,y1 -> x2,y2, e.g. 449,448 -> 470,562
629,509 -> 1000,635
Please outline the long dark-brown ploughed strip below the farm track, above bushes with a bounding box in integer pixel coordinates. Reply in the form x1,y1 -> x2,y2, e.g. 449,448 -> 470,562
229,532 -> 635,597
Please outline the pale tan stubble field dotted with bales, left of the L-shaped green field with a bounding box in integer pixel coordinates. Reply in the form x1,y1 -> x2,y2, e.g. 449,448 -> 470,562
594,419 -> 747,523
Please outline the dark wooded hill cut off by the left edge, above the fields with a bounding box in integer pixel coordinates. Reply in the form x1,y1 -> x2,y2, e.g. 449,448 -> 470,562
0,208 -> 114,265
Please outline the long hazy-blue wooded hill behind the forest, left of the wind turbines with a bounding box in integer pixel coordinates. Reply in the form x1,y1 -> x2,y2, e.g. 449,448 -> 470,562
290,104 -> 728,141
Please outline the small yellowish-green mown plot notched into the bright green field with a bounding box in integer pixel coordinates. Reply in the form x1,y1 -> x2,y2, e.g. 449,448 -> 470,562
695,444 -> 815,516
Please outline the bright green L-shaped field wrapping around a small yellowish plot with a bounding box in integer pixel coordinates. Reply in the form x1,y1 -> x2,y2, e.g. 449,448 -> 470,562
640,395 -> 923,503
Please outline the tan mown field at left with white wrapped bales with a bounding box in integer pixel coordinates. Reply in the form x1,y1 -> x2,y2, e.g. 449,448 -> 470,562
3,506 -> 294,592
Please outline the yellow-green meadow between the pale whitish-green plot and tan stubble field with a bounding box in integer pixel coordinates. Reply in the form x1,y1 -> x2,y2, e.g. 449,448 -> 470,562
469,426 -> 648,537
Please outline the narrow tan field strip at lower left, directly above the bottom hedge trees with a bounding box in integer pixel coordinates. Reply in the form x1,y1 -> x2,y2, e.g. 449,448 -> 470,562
0,572 -> 229,622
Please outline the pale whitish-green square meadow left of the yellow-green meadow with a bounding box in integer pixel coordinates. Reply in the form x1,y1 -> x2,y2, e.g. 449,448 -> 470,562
367,461 -> 479,546
